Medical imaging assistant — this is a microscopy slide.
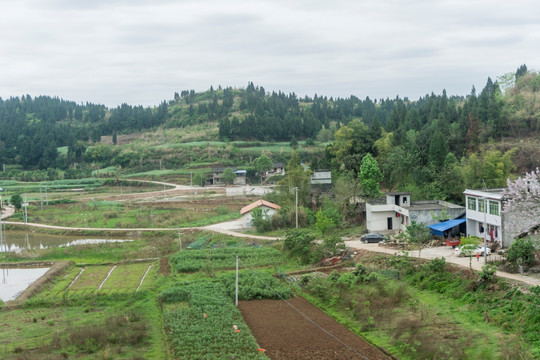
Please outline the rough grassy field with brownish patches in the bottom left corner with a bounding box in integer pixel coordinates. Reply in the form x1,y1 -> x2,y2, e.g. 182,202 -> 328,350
0,293 -> 167,360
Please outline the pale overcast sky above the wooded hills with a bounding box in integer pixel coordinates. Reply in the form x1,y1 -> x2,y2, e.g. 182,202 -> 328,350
0,0 -> 540,107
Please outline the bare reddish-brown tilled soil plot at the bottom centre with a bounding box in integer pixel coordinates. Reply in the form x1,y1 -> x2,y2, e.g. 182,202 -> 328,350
239,297 -> 390,360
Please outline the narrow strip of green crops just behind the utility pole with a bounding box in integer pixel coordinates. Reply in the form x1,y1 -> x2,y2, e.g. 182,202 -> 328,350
170,247 -> 284,272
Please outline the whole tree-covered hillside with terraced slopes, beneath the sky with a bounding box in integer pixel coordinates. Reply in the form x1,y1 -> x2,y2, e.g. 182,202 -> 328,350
0,65 -> 540,201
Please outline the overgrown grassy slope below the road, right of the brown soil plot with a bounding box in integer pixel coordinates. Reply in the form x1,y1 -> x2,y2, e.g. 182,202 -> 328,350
300,256 -> 540,359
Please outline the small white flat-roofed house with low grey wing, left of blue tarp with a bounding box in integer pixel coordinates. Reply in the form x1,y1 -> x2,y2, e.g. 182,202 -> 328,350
366,192 -> 465,234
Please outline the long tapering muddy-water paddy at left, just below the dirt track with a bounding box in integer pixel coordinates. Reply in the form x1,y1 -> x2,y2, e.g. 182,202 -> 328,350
0,230 -> 133,252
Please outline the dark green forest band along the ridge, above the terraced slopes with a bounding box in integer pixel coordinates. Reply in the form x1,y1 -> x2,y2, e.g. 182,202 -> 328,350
0,66 -> 540,169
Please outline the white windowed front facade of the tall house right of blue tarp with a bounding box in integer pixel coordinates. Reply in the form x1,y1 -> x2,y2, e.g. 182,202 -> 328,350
463,189 -> 513,247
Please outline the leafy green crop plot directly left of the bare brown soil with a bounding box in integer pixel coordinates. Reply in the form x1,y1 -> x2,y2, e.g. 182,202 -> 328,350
160,281 -> 266,360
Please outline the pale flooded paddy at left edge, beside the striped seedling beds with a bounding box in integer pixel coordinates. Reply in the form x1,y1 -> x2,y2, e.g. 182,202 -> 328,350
0,268 -> 49,301
